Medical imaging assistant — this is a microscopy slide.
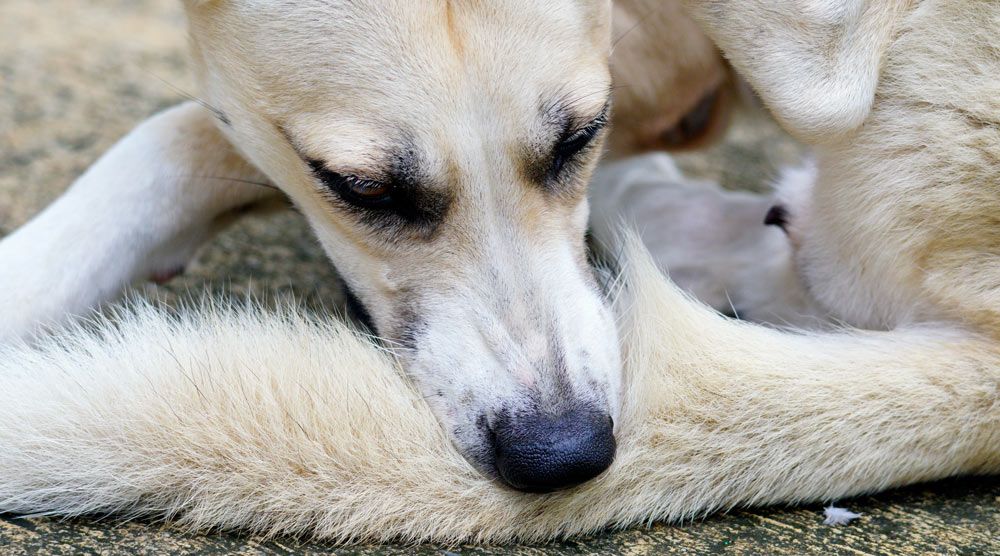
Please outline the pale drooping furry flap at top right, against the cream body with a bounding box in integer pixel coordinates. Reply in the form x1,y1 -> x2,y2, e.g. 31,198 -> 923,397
685,0 -> 915,143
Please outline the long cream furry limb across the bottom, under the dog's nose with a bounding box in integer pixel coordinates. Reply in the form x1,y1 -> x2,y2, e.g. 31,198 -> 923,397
0,236 -> 1000,542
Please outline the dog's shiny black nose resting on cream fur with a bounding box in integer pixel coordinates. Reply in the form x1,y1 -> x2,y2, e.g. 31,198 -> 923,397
494,410 -> 615,492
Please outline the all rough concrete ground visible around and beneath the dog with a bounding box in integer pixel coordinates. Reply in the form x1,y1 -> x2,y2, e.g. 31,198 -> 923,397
0,0 -> 1000,555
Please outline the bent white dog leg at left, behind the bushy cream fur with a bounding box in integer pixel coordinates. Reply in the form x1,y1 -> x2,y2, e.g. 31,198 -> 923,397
0,103 -> 279,343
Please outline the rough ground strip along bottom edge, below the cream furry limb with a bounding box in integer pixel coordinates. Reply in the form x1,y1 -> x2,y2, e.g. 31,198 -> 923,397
0,477 -> 1000,556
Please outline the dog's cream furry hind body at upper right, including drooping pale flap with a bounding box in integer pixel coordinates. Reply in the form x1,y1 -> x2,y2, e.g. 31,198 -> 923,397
624,0 -> 1000,337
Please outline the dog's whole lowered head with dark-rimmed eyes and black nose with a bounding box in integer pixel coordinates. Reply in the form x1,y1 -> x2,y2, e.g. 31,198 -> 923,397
180,0 -> 621,490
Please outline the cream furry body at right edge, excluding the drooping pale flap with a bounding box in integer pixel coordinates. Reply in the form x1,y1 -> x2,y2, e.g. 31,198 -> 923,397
779,1 -> 1000,337
